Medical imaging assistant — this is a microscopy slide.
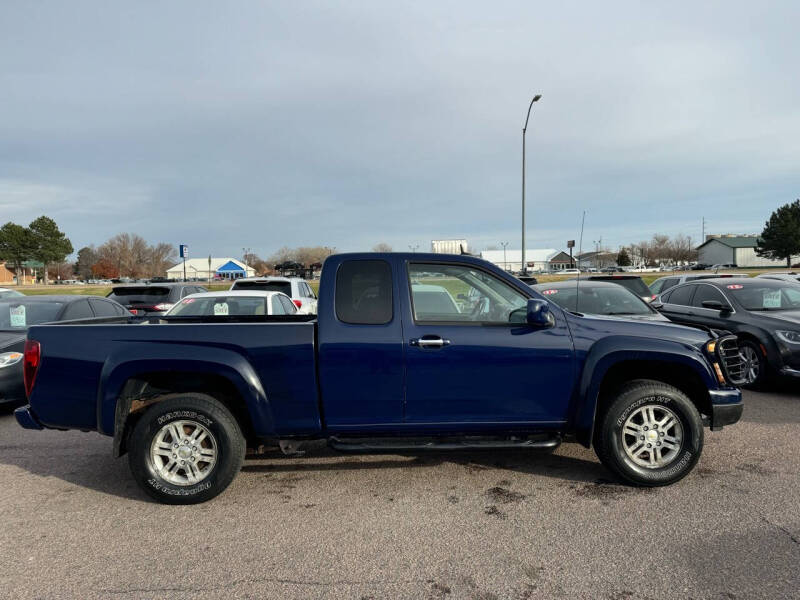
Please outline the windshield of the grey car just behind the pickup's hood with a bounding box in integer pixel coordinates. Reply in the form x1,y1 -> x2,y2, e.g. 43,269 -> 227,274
541,283 -> 656,315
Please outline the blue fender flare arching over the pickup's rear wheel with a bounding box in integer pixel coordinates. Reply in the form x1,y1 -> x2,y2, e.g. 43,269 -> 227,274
97,342 -> 274,436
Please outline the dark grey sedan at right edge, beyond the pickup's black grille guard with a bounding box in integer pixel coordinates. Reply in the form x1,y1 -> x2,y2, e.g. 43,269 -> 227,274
656,277 -> 800,386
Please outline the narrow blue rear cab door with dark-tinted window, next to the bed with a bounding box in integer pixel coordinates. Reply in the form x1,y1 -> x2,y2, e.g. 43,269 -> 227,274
318,258 -> 405,433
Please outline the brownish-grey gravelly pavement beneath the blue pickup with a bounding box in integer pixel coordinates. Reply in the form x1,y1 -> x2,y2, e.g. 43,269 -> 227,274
0,391 -> 800,600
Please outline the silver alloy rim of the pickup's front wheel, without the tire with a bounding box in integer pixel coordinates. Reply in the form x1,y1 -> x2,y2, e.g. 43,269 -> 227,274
622,404 -> 683,469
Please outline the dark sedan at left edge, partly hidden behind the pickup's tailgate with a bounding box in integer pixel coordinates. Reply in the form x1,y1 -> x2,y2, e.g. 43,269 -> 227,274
0,295 -> 131,406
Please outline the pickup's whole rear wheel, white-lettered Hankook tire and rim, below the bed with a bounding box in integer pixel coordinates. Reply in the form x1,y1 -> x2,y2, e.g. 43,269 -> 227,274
128,393 -> 246,504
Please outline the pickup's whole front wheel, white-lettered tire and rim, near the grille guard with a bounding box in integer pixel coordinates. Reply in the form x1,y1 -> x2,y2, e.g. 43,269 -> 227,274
595,379 -> 703,487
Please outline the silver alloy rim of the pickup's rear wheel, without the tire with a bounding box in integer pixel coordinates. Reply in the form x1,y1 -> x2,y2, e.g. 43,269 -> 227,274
150,421 -> 217,485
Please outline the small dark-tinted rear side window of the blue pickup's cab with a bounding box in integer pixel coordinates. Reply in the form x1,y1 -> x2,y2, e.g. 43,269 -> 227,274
334,260 -> 394,325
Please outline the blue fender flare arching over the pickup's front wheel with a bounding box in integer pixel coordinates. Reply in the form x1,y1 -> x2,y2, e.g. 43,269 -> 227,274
573,336 -> 718,448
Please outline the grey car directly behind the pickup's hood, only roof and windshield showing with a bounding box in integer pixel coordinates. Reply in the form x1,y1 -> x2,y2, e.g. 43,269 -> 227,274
533,280 -> 669,321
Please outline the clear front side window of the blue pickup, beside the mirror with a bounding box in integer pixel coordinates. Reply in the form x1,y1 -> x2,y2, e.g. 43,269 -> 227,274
408,264 -> 528,323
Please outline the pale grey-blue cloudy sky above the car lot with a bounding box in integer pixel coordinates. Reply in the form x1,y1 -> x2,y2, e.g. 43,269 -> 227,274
0,0 -> 800,256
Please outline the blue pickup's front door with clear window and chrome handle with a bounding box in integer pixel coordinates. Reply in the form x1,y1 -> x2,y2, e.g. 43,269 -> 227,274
403,262 -> 574,429
